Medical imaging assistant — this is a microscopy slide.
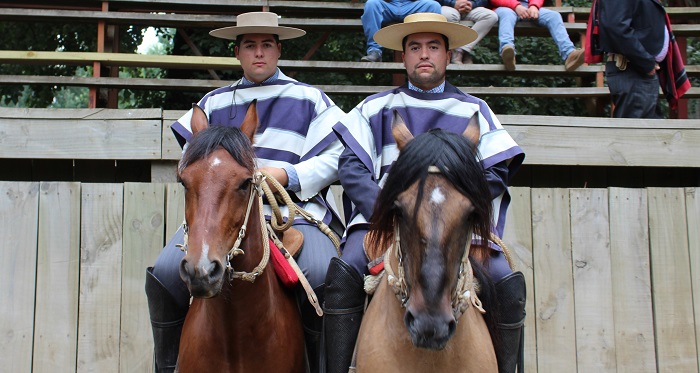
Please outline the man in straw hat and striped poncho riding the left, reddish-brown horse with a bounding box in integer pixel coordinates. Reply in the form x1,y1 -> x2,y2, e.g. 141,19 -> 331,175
146,12 -> 345,372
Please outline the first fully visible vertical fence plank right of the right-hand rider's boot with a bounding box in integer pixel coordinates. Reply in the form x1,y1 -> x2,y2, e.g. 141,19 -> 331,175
531,189 -> 577,373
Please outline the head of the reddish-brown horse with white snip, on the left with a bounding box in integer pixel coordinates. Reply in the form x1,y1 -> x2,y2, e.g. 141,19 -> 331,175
178,102 -> 258,298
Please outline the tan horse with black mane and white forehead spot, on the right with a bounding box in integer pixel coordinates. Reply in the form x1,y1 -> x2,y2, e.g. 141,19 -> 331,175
356,112 -> 498,373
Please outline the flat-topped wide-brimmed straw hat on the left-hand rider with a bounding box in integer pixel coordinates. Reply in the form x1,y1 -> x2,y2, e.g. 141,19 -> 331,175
209,12 -> 306,40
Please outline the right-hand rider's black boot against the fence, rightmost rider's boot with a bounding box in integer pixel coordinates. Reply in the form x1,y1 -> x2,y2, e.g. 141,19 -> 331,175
496,272 -> 525,373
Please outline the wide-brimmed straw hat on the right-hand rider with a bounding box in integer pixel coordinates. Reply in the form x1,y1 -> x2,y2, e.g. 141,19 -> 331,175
374,13 -> 478,51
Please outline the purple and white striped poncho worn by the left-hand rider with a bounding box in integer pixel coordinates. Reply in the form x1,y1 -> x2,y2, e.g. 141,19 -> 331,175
172,70 -> 345,224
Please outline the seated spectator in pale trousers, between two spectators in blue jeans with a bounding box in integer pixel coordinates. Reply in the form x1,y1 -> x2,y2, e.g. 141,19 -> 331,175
442,0 -> 498,65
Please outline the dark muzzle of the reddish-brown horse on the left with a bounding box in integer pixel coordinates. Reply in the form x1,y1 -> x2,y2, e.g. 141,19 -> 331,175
180,256 -> 226,298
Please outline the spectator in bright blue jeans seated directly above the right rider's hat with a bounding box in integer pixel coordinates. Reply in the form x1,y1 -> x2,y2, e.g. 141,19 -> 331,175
360,0 -> 466,62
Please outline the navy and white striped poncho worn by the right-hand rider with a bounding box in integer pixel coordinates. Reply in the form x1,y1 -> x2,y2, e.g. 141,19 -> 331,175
333,83 -> 524,236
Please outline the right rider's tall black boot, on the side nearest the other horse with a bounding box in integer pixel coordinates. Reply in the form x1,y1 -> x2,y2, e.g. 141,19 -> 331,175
323,258 -> 365,373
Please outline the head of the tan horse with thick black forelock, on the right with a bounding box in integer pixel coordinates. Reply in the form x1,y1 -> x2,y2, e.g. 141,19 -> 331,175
370,109 -> 491,350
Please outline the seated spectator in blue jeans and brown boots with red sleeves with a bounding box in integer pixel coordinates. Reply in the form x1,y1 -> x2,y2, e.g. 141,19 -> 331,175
490,0 -> 584,71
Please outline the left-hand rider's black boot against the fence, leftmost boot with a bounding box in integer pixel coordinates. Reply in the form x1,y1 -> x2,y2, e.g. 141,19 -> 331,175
146,267 -> 187,373
